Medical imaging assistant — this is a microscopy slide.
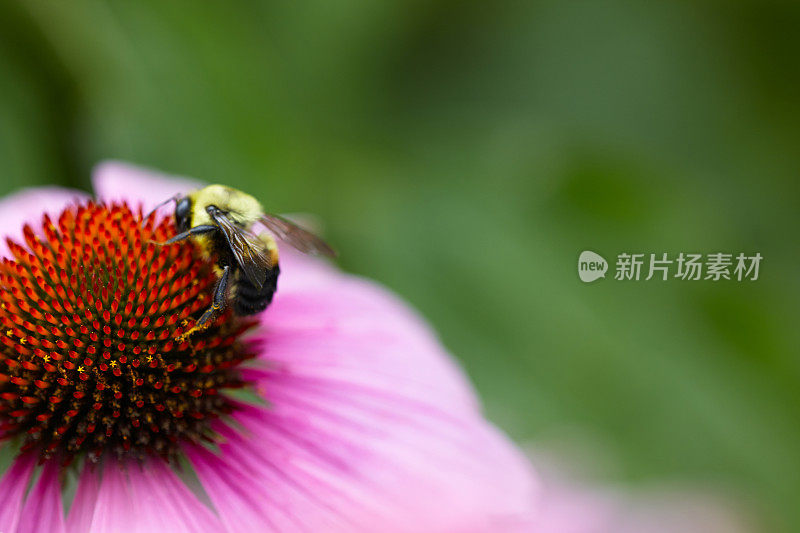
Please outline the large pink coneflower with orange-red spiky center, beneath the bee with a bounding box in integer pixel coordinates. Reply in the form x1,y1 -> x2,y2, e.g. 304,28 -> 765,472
0,163 -> 535,533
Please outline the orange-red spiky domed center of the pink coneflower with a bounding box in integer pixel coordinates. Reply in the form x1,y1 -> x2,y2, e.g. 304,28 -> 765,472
0,202 -> 251,461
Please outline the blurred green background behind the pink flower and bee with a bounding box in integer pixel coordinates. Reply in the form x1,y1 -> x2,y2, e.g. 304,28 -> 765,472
0,0 -> 800,531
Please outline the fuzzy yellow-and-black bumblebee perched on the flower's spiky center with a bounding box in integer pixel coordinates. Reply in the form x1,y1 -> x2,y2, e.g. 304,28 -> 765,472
148,185 -> 336,340
